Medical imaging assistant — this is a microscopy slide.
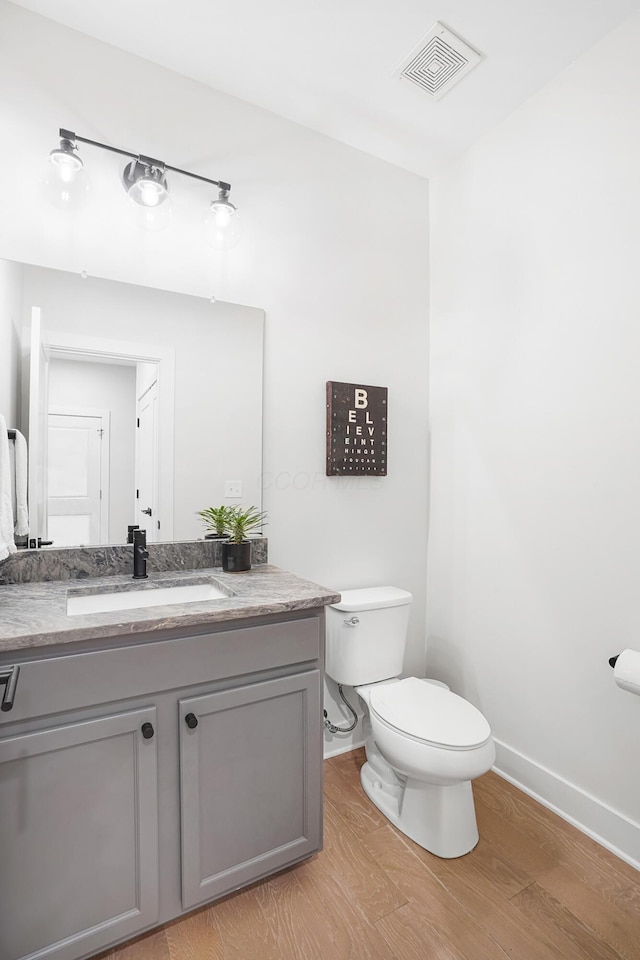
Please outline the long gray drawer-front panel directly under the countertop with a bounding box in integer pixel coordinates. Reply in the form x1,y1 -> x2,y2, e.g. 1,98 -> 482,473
0,616 -> 322,731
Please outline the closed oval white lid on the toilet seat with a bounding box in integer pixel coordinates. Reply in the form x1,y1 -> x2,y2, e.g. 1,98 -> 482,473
370,677 -> 491,749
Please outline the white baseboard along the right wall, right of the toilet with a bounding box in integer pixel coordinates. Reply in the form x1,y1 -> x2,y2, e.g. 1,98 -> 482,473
493,740 -> 640,870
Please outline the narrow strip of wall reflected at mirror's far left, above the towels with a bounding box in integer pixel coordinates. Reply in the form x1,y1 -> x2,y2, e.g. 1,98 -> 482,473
0,260 -> 22,427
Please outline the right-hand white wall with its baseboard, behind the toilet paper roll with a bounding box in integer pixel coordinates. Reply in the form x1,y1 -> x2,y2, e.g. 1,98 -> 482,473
427,9 -> 640,862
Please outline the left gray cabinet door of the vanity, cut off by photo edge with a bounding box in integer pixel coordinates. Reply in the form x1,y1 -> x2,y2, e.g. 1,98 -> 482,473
0,707 -> 158,960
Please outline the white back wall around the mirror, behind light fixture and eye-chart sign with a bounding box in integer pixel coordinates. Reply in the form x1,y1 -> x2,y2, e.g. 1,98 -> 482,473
0,0 -> 428,752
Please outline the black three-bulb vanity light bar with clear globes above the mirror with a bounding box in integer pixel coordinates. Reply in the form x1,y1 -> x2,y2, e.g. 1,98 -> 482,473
46,128 -> 240,249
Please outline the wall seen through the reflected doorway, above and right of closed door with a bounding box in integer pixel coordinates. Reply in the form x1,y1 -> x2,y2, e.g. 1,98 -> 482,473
49,359 -> 136,543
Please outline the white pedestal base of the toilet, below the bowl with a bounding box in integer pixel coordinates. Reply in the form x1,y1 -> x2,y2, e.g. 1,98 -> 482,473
360,742 -> 479,860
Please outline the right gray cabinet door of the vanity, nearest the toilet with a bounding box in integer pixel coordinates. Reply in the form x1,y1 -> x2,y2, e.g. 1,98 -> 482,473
179,670 -> 322,909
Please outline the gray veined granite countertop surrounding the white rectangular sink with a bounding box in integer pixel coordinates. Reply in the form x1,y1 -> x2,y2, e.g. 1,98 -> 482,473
0,564 -> 340,654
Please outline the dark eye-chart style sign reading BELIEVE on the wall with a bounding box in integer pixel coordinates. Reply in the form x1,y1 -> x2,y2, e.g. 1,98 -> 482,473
327,380 -> 388,477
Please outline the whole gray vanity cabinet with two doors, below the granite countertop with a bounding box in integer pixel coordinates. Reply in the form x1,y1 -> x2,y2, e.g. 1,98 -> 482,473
0,608 -> 324,960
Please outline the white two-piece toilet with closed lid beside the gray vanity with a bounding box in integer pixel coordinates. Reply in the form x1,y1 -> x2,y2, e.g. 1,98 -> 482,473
326,587 -> 495,859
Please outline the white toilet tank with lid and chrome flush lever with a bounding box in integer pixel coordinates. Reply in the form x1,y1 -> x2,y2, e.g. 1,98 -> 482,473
325,587 -> 413,687
